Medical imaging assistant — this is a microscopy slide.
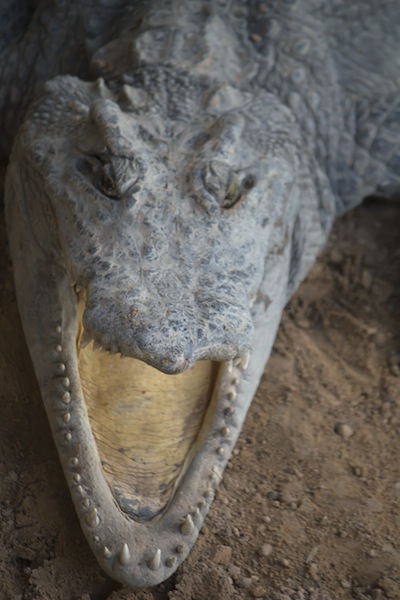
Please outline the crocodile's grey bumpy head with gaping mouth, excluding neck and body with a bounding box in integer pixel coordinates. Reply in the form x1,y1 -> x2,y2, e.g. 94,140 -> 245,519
6,75 -> 298,587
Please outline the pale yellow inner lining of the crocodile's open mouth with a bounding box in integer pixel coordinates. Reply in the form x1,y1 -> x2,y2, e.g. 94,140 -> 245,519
77,310 -> 218,520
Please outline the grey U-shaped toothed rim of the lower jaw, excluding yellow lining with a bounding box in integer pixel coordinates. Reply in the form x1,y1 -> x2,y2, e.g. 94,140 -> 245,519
38,288 -> 252,588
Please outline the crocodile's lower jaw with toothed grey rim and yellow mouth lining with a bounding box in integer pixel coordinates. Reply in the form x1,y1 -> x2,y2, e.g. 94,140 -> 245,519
42,282 -> 252,588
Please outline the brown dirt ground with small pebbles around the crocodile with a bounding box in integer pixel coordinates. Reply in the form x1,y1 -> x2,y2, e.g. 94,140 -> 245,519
0,201 -> 400,600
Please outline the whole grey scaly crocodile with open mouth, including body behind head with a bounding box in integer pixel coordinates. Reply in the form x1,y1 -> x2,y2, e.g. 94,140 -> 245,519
0,0 -> 400,588
